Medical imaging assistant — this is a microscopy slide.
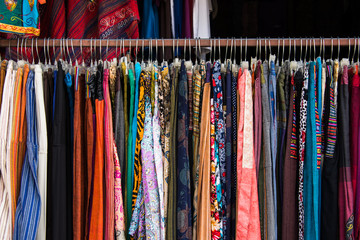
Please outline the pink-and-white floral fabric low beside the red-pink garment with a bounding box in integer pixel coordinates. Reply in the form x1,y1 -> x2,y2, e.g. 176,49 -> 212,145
114,141 -> 125,240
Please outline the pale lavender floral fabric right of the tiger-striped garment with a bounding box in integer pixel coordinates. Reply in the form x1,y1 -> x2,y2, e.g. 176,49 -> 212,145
141,96 -> 162,239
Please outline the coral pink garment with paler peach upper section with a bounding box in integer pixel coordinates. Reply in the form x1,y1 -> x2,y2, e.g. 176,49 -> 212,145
236,69 -> 261,240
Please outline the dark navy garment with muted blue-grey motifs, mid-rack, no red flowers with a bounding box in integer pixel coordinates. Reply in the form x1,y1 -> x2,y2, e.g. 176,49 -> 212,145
176,61 -> 192,240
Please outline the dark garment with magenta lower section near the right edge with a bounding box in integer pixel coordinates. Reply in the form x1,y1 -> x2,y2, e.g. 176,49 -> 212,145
336,66 -> 354,240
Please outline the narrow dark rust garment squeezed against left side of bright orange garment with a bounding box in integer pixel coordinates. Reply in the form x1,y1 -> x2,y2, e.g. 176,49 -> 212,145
84,98 -> 95,239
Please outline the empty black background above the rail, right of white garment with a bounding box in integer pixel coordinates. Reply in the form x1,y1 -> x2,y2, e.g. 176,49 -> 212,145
211,0 -> 360,38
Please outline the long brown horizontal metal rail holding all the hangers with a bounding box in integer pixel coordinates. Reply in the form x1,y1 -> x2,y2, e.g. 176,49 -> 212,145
0,38 -> 356,48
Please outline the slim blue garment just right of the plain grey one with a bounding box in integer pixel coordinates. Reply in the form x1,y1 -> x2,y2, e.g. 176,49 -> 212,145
269,61 -> 277,239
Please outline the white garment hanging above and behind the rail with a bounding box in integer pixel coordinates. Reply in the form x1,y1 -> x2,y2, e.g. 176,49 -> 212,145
193,0 -> 212,38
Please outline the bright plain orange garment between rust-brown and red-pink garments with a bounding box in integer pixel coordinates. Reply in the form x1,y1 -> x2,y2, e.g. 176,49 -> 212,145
89,99 -> 105,239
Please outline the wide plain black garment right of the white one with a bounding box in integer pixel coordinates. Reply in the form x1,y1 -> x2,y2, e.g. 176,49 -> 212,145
46,62 -> 73,240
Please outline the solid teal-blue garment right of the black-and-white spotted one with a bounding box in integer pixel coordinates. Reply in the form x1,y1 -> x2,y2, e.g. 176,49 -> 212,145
304,62 -> 320,240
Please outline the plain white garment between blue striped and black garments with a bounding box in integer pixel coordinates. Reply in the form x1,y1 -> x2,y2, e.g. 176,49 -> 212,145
35,65 -> 48,240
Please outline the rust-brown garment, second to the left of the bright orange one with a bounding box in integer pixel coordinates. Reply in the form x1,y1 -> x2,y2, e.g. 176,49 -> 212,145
73,75 -> 86,240
